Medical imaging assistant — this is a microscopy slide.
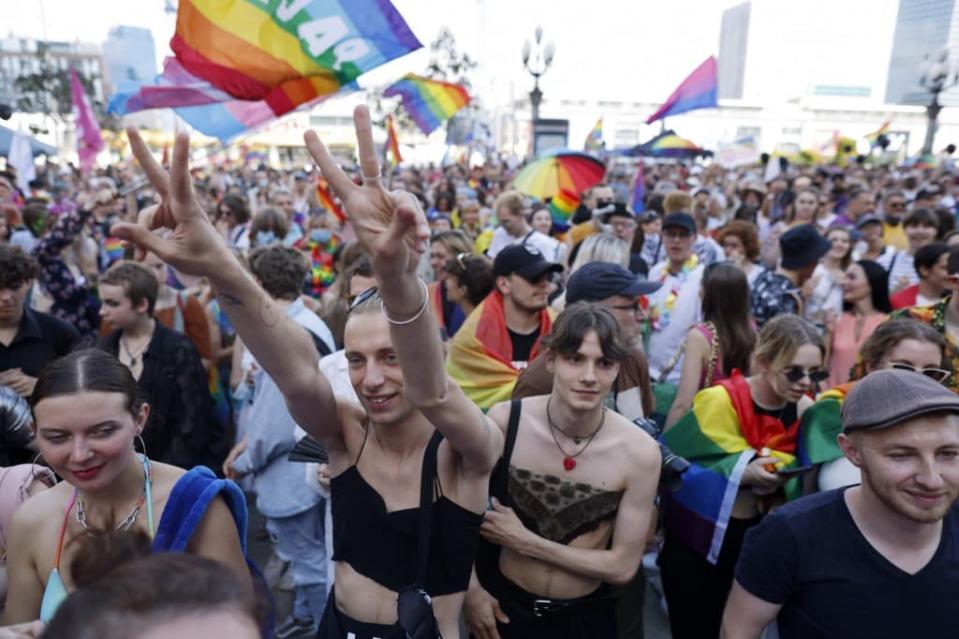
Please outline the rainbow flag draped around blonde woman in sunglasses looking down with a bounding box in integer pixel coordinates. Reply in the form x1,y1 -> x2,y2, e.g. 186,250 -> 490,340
662,373 -> 802,564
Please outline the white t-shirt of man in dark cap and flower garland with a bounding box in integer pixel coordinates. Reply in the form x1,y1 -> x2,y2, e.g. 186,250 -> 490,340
646,260 -> 705,383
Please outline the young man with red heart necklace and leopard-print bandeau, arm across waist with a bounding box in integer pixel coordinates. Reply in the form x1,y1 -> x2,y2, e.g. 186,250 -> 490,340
465,303 -> 661,639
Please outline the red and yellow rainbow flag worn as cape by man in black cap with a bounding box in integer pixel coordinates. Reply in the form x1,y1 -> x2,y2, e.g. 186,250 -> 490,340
446,291 -> 553,411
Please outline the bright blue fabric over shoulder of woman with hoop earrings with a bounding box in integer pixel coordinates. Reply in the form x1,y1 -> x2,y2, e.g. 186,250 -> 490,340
153,466 -> 247,556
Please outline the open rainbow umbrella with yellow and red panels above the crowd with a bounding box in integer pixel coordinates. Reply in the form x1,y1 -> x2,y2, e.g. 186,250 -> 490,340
513,151 -> 606,200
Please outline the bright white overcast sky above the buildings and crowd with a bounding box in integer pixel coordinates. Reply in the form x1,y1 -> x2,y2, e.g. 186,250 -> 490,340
0,0 -> 898,109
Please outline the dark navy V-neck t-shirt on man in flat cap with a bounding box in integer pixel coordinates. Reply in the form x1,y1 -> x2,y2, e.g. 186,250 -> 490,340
736,489 -> 959,639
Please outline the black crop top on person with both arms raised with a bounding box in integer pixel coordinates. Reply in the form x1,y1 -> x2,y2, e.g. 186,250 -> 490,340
330,430 -> 483,597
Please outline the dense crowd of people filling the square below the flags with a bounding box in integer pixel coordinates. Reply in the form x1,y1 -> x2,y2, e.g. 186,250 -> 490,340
0,107 -> 959,639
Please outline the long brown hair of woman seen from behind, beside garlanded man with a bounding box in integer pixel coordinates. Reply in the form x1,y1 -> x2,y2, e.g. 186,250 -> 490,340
702,262 -> 756,374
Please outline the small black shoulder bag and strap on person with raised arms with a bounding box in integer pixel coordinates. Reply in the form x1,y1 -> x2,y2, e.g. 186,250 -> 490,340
396,431 -> 443,639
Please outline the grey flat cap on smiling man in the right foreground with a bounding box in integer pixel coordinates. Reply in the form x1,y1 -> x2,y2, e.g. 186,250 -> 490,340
842,369 -> 959,433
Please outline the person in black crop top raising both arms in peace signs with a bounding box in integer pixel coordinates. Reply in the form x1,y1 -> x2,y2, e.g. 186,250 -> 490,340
114,107 -> 502,639
